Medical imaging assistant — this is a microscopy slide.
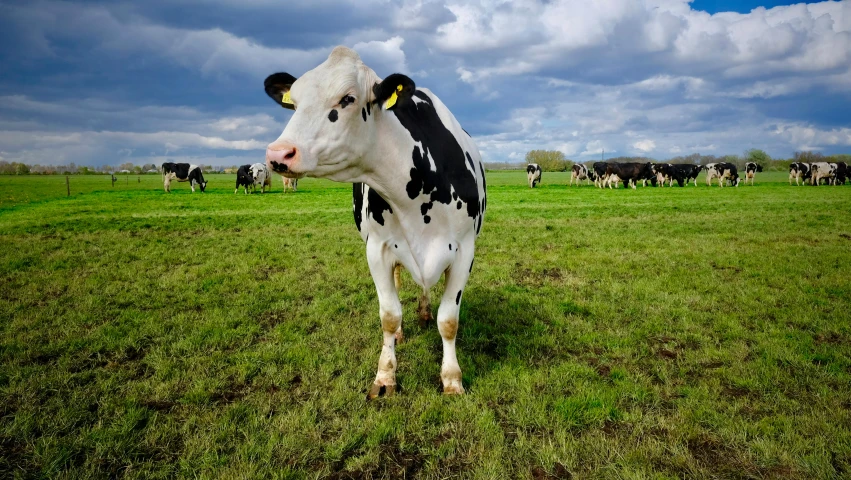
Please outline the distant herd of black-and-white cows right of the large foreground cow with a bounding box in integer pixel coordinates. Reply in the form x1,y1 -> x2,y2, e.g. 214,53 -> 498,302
526,162 -> 851,188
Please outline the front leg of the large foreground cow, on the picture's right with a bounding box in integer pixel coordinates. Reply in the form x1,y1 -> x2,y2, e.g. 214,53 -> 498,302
437,248 -> 475,395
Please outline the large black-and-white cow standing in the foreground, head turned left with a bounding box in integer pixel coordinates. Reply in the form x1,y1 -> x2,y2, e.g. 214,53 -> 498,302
264,47 -> 487,399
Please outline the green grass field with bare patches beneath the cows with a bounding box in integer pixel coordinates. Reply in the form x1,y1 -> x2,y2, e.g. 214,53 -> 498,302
0,172 -> 851,479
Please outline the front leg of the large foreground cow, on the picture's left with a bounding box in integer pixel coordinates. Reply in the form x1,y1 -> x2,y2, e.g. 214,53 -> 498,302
366,241 -> 402,399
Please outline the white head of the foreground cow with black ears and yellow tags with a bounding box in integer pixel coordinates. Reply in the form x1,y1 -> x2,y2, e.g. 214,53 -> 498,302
265,47 -> 416,180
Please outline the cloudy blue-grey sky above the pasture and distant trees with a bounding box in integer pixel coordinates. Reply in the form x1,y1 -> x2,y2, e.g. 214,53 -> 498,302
0,0 -> 851,166
